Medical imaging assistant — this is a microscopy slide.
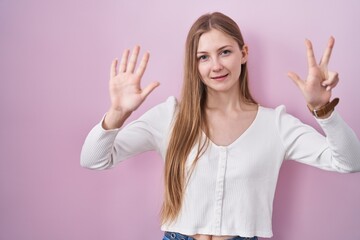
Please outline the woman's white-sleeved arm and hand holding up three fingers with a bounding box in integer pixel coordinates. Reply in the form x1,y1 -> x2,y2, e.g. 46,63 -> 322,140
284,37 -> 360,172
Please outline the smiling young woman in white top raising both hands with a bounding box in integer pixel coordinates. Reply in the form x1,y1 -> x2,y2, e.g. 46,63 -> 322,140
81,13 -> 360,240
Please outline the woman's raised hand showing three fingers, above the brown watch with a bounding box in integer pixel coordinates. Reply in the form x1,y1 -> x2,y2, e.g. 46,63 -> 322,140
288,37 -> 339,109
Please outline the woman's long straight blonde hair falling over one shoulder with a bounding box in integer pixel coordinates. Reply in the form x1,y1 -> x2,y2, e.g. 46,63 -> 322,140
161,12 -> 256,223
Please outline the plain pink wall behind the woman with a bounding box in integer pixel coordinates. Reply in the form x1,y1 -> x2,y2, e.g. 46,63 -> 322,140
0,0 -> 360,240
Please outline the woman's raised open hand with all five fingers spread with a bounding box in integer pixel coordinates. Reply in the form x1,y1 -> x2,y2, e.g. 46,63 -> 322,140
103,46 -> 159,129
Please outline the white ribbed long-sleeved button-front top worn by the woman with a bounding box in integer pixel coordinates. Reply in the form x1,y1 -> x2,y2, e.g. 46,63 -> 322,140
81,97 -> 360,237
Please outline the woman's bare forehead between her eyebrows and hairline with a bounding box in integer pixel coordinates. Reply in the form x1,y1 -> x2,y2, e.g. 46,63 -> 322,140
198,29 -> 238,52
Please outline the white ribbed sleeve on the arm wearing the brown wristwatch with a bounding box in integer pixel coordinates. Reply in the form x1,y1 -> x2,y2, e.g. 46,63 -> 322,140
276,107 -> 360,173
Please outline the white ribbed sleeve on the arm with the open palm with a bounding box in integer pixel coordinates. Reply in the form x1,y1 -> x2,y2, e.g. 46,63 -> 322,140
80,97 -> 176,169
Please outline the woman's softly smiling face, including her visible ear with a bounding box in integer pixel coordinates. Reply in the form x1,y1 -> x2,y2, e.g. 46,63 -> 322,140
197,29 -> 247,93
